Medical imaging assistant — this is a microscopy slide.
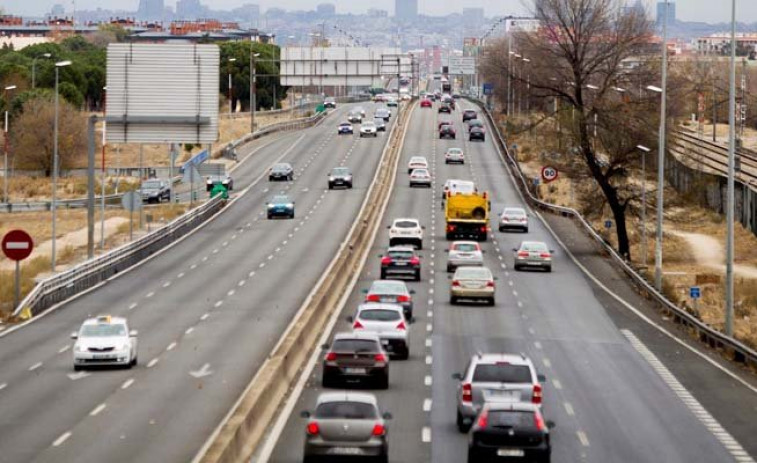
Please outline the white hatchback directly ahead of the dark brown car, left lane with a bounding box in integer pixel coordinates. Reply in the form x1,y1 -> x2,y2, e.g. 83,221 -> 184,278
347,303 -> 410,360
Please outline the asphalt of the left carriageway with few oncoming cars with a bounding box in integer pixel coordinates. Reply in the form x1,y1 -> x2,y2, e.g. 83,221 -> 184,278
0,103 -> 396,462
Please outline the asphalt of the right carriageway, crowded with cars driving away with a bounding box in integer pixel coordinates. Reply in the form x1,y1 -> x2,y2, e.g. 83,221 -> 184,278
260,102 -> 755,463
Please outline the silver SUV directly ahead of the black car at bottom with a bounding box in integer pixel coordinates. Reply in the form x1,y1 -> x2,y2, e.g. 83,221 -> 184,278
452,353 -> 546,432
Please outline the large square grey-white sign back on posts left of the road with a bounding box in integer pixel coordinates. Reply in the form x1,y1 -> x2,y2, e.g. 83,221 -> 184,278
105,43 -> 220,143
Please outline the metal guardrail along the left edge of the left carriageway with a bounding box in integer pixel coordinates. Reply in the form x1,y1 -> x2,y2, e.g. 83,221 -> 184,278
8,107 -> 334,316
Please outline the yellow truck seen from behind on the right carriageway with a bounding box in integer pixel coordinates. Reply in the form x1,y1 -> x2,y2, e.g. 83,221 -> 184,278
444,192 -> 492,241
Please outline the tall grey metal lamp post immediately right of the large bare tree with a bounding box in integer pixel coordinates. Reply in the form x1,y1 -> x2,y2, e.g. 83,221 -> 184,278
654,0 -> 669,291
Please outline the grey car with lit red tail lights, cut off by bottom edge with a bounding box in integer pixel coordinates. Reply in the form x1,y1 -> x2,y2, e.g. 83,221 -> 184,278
300,391 -> 392,463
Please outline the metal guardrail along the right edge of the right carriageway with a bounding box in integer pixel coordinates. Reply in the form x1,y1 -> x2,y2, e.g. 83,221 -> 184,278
472,100 -> 757,366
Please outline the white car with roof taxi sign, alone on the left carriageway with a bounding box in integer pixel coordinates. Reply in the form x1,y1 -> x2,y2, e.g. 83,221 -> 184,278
71,315 -> 137,371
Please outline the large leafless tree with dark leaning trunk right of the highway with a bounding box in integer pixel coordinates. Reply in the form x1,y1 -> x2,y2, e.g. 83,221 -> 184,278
487,0 -> 659,258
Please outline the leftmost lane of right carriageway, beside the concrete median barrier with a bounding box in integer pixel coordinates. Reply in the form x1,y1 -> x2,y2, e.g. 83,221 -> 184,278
269,103 -> 436,462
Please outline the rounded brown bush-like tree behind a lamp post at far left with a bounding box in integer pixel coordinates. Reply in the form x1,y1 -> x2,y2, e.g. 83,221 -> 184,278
11,95 -> 87,175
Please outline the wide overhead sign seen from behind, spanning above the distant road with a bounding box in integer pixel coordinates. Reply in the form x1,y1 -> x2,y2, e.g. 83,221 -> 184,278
280,47 -> 411,86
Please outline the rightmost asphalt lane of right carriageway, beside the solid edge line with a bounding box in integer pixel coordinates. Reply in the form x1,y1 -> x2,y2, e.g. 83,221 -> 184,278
452,99 -> 729,461
